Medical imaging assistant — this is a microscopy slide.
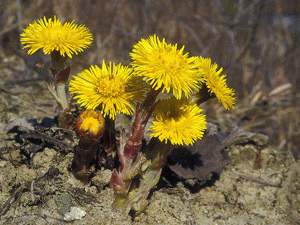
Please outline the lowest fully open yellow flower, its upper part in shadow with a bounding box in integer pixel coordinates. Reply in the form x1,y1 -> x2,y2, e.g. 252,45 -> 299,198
150,98 -> 206,145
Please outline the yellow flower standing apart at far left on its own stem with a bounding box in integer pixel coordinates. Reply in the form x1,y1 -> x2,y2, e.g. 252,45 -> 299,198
21,16 -> 93,58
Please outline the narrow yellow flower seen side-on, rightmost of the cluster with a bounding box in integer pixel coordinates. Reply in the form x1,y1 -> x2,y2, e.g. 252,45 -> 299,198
197,57 -> 236,110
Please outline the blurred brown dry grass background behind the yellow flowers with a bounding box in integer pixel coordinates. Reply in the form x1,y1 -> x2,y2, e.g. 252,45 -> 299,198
0,0 -> 300,158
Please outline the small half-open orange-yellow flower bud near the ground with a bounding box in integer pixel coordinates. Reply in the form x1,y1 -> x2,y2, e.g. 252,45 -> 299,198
76,110 -> 105,138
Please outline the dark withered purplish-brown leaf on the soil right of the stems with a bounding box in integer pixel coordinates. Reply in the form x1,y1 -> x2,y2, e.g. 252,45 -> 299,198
168,126 -> 268,188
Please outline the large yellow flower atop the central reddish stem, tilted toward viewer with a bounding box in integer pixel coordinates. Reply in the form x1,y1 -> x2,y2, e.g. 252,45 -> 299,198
130,35 -> 199,99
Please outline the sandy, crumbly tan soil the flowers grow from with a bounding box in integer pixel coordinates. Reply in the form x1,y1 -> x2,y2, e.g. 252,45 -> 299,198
0,56 -> 300,225
